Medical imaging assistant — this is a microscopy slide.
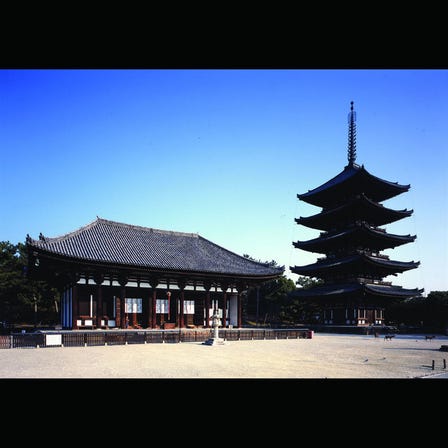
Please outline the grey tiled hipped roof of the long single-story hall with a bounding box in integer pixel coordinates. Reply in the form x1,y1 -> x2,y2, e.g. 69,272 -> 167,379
27,218 -> 284,277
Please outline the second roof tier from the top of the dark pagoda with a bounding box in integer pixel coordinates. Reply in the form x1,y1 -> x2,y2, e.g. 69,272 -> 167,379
295,194 -> 413,230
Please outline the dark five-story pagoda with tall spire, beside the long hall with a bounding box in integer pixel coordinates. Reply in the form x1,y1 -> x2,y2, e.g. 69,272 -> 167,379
291,101 -> 423,326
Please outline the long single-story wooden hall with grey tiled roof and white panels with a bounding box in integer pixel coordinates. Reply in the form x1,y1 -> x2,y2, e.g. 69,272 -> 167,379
26,218 -> 284,329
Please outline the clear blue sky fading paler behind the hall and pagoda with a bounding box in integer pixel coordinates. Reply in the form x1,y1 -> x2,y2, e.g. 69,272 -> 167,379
0,69 -> 448,294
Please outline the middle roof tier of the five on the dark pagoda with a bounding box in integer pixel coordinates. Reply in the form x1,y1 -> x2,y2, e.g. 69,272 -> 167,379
293,222 -> 416,254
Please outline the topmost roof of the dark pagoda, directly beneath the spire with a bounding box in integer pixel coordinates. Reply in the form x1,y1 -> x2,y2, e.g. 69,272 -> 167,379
297,164 -> 410,208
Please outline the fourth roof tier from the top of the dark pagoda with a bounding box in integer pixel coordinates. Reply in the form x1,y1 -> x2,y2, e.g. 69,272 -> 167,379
290,255 -> 420,277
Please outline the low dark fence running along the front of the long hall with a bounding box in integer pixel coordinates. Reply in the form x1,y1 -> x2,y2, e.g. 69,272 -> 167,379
0,329 -> 313,349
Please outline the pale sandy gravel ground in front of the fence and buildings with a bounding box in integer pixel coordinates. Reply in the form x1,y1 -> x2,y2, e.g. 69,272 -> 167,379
0,333 -> 448,379
